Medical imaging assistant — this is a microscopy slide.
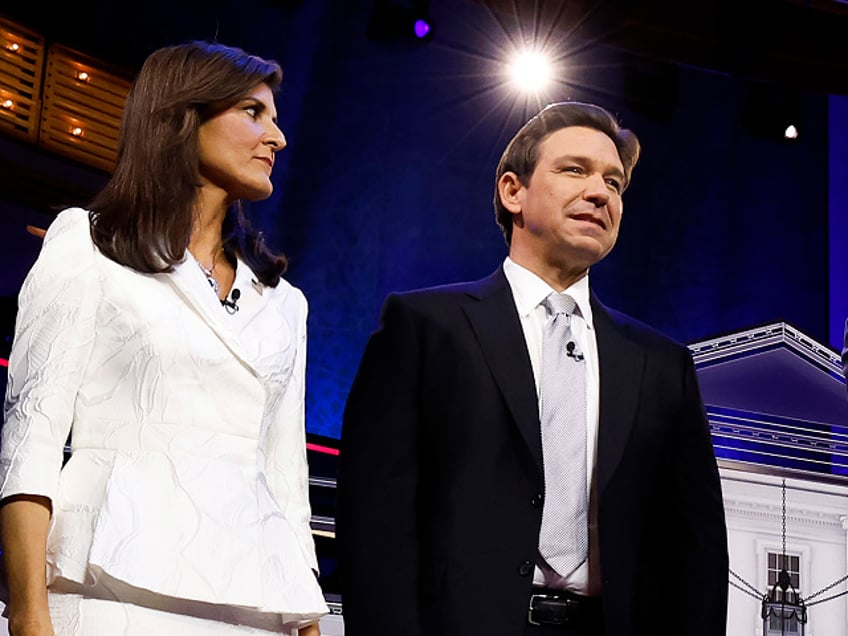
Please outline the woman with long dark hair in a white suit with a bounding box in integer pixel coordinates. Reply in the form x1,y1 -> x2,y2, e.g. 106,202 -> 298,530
0,42 -> 327,636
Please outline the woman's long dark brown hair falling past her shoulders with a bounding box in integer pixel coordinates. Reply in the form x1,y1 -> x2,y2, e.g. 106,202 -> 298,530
88,42 -> 288,287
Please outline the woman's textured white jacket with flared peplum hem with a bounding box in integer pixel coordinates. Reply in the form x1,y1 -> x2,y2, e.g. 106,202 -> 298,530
0,208 -> 328,623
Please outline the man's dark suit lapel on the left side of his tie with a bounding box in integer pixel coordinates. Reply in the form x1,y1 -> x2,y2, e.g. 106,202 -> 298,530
465,269 -> 542,473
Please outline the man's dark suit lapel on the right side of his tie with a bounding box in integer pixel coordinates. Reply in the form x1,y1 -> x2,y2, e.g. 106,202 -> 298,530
592,295 -> 645,494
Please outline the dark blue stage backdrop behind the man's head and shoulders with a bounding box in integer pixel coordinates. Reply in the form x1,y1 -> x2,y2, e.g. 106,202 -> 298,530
258,2 -> 828,437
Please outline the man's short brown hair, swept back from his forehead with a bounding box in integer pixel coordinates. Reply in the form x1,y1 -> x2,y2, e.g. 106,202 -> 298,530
494,102 -> 641,245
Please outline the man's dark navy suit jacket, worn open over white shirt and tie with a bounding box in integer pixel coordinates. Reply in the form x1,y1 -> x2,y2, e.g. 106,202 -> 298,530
336,269 -> 728,636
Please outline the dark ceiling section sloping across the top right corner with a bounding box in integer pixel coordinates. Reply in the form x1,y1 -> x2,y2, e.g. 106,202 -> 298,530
477,0 -> 848,95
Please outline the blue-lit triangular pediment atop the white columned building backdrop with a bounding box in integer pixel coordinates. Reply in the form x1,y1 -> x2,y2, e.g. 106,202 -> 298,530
689,323 -> 848,479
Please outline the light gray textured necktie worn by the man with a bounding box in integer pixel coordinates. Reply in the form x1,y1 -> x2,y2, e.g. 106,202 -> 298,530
539,293 -> 589,576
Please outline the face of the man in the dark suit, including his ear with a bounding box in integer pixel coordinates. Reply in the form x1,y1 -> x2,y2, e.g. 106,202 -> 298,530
507,126 -> 624,272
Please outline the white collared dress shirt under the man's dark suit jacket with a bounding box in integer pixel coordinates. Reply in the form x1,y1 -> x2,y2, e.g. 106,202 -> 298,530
503,257 -> 600,594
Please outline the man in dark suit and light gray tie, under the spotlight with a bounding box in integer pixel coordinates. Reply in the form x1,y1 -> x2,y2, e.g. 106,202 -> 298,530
337,102 -> 728,636
